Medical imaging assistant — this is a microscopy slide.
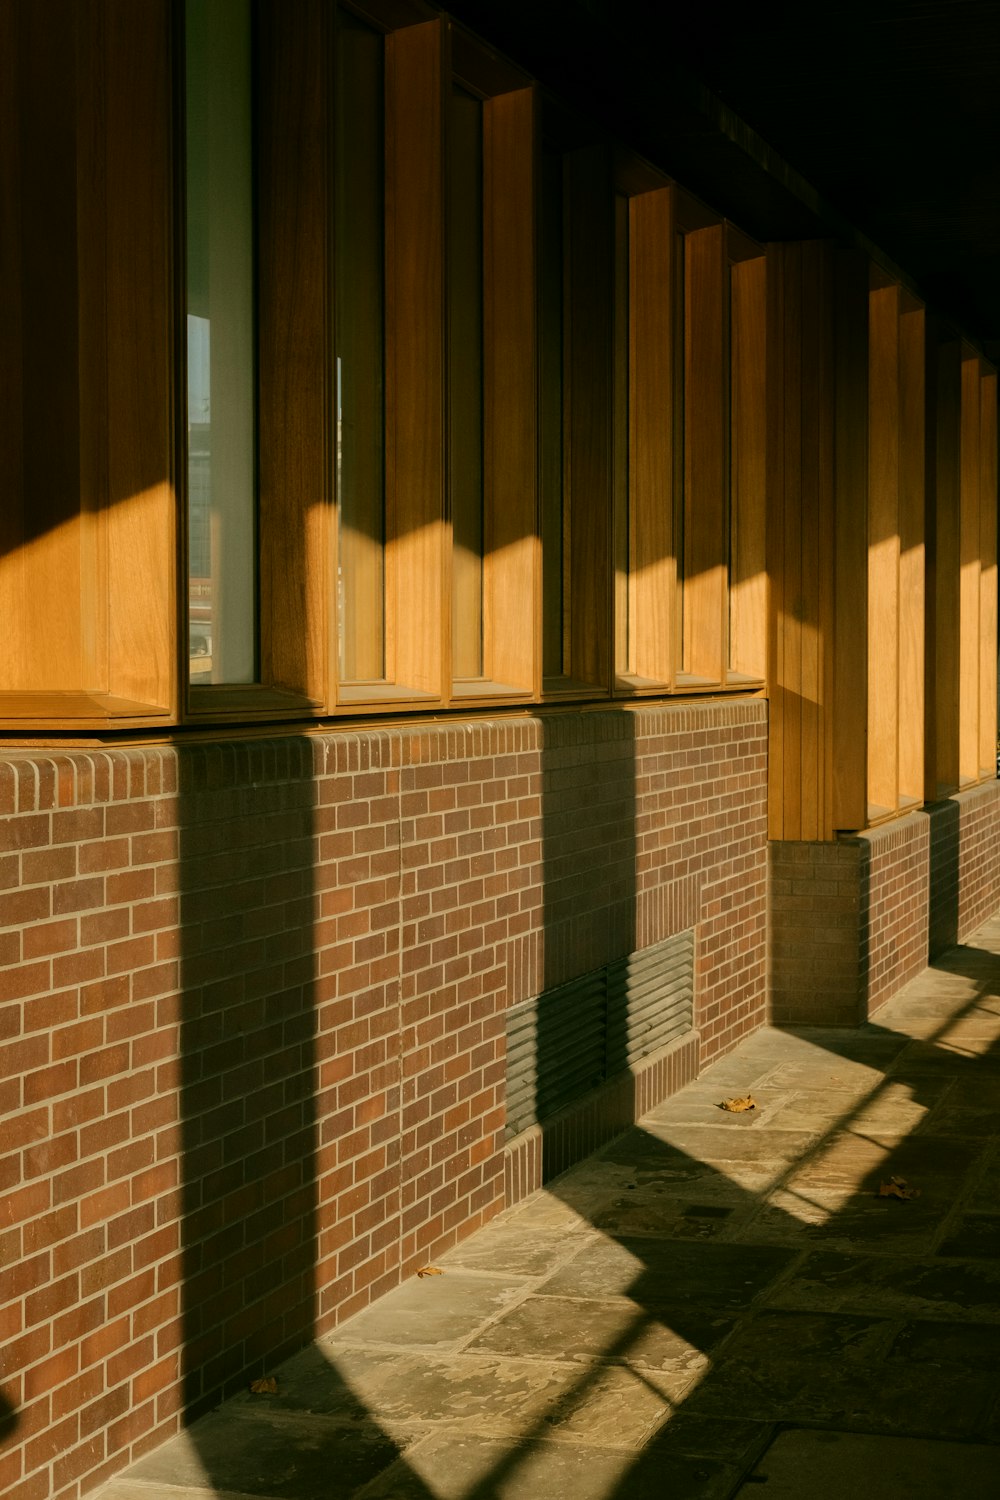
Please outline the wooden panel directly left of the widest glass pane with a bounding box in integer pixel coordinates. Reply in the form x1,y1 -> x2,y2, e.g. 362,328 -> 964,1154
102,0 -> 177,711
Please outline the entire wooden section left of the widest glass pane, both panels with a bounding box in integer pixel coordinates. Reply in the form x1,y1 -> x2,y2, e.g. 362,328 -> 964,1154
0,0 -> 177,726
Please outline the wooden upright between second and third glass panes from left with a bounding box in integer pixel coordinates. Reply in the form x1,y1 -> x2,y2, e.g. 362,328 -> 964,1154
385,21 -> 451,696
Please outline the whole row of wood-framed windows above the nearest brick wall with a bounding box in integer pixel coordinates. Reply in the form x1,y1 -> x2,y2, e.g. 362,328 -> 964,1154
0,0 -> 779,728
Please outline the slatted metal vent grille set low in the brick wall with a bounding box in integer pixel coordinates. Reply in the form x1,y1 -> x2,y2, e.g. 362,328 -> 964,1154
507,932 -> 694,1140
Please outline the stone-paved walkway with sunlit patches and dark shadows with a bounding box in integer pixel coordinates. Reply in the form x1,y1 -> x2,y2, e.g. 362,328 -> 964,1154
102,920 -> 1000,1500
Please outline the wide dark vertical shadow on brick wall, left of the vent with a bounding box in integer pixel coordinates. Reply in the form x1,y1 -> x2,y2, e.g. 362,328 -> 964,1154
177,738 -> 316,1418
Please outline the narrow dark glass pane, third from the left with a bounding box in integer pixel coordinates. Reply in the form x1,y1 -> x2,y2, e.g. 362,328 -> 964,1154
448,89 -> 483,678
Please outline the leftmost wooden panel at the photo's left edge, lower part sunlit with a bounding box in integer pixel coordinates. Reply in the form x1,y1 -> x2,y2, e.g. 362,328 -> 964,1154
0,3 -> 85,690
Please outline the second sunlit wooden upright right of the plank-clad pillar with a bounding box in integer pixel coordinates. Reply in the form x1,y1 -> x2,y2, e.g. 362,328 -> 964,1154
900,297 -> 925,801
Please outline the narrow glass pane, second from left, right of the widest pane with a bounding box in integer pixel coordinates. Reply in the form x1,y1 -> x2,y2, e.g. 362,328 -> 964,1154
336,12 -> 385,683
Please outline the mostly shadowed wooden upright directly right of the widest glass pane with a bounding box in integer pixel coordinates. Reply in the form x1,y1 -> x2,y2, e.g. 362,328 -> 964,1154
258,0 -> 329,702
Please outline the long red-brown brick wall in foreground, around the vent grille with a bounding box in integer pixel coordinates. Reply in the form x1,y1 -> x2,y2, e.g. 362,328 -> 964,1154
0,701 -> 765,1500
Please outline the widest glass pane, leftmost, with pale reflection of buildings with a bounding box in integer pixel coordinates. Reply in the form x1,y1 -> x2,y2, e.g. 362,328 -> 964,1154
186,0 -> 256,683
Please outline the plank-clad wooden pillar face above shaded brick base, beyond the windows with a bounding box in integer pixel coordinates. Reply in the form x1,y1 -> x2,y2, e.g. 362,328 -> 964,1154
773,242 -> 851,840
